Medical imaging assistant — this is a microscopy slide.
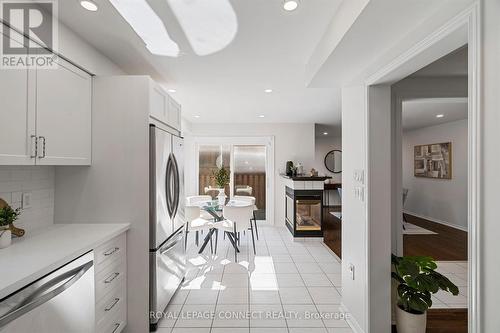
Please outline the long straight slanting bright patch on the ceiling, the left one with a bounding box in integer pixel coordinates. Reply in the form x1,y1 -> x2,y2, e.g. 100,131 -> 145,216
110,0 -> 180,57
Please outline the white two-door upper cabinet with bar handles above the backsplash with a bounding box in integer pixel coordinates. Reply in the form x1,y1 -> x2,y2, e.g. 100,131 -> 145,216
0,26 -> 92,165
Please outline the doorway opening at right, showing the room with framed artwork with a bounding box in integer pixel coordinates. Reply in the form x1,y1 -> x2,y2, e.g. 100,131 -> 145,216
391,46 -> 469,333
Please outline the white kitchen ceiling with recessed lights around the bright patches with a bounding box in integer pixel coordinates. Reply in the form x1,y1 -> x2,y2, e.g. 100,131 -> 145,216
59,0 -> 341,123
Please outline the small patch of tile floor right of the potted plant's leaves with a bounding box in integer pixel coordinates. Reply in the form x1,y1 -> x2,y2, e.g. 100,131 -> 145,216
432,261 -> 468,309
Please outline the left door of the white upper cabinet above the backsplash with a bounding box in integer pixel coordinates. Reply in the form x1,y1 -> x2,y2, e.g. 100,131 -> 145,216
0,30 -> 36,165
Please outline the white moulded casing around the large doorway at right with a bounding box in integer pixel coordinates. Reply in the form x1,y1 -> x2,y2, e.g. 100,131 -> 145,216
364,2 -> 481,333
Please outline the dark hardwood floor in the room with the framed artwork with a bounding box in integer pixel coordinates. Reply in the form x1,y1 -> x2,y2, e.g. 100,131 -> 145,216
403,214 -> 467,261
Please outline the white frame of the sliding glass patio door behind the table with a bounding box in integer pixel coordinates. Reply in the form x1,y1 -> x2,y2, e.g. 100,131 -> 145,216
193,136 -> 275,223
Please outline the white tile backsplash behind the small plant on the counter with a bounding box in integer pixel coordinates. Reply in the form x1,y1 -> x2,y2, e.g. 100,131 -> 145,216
0,166 -> 55,232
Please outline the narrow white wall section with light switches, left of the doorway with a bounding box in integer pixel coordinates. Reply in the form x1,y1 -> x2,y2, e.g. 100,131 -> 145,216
342,86 -> 368,331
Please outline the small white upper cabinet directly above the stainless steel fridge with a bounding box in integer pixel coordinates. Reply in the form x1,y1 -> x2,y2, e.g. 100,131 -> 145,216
149,80 -> 181,131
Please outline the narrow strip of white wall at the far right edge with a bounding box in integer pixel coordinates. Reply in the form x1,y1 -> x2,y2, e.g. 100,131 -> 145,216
478,0 -> 500,333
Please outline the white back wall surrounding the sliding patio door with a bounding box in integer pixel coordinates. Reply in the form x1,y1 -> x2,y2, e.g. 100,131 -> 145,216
186,123 -> 316,225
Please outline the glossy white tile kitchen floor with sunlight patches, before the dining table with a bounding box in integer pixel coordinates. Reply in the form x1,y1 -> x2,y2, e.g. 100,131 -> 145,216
157,225 -> 352,333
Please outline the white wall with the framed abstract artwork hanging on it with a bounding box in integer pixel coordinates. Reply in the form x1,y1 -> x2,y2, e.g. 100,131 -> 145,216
403,119 -> 468,230
